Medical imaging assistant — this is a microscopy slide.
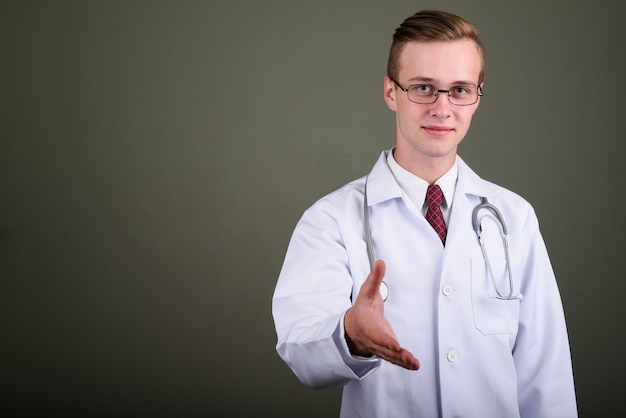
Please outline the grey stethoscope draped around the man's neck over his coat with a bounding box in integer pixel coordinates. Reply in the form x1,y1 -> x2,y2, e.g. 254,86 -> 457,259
363,179 -> 522,301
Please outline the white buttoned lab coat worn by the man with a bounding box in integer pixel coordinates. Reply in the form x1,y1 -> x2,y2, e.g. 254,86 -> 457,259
272,151 -> 577,418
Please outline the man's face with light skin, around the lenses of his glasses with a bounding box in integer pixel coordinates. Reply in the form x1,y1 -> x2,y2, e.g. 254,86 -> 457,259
384,39 -> 482,168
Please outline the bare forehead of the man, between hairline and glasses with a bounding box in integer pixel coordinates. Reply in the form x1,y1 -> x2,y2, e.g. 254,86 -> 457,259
399,39 -> 482,83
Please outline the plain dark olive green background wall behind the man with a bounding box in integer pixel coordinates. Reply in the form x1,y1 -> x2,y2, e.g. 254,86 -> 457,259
0,0 -> 626,417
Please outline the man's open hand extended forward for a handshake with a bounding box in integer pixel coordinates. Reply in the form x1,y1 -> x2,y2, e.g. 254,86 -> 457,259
344,260 -> 420,370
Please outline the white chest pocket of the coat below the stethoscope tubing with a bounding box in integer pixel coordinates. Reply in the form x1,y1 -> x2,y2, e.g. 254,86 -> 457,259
470,258 -> 520,335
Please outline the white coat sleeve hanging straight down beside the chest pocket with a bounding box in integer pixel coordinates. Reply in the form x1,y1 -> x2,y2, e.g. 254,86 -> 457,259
513,209 -> 577,418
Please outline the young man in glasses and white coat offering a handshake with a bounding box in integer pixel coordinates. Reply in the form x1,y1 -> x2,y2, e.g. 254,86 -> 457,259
273,11 -> 577,418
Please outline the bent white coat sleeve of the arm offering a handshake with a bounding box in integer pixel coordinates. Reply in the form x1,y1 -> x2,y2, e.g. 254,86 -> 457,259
272,198 -> 381,389
